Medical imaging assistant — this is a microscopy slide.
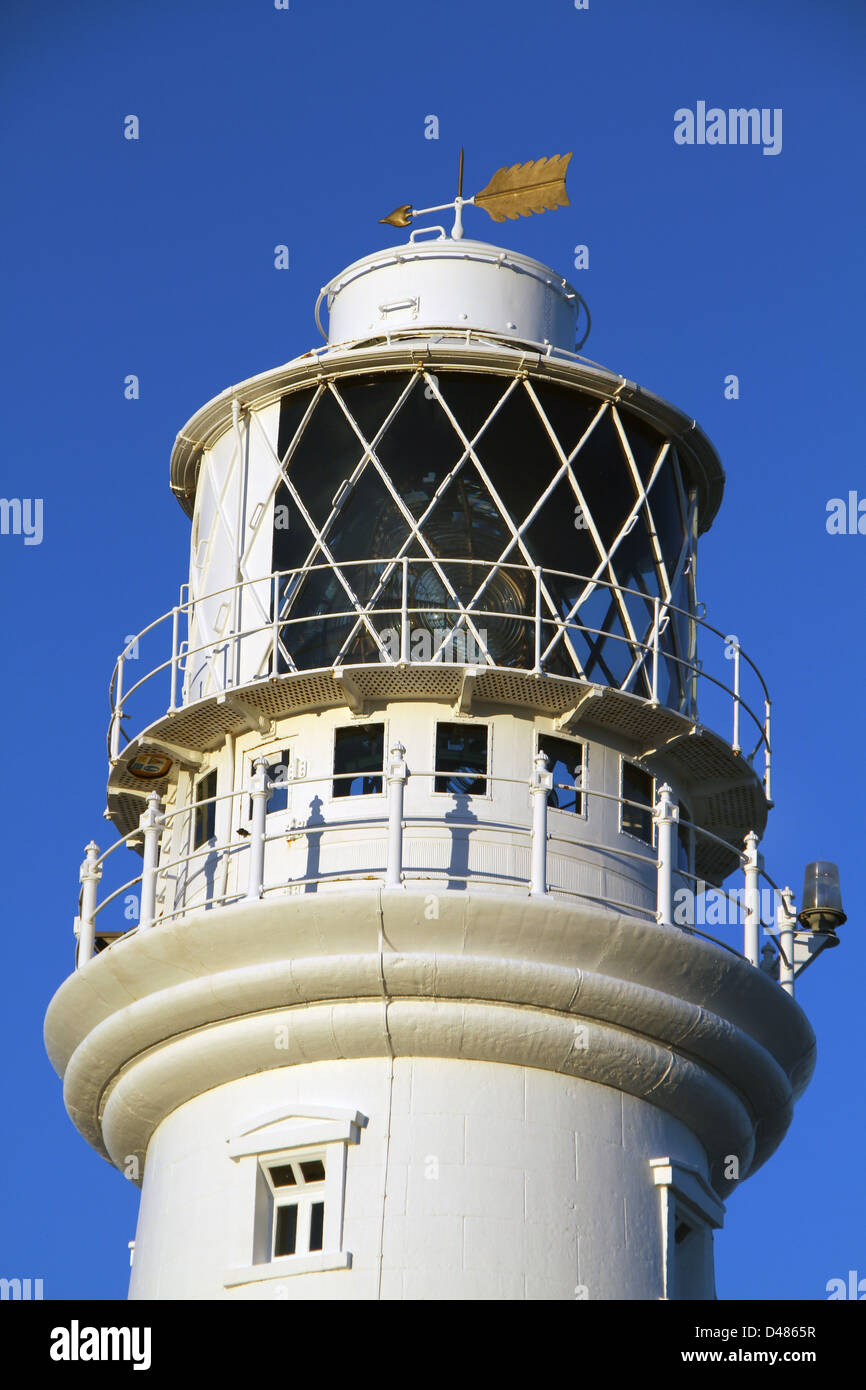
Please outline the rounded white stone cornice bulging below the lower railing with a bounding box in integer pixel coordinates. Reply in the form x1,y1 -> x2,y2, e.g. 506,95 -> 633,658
46,890 -> 815,1190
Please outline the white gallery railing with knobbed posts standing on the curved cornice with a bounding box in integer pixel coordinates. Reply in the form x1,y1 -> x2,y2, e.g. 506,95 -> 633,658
75,741 -> 795,994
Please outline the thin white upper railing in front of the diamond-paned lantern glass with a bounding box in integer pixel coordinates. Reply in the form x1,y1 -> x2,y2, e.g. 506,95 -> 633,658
108,556 -> 771,799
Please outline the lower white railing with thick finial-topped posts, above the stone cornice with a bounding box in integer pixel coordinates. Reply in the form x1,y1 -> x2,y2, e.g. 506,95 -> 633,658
79,742 -> 794,992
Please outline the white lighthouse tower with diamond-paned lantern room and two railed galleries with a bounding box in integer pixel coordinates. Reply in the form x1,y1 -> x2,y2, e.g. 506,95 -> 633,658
46,162 -> 844,1300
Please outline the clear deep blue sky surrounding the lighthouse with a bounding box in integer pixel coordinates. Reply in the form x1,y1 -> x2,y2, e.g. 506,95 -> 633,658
0,0 -> 866,1298
